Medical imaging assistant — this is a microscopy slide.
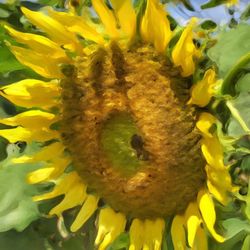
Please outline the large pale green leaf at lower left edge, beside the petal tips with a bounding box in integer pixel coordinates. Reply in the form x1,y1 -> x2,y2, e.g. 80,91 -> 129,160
0,144 -> 40,232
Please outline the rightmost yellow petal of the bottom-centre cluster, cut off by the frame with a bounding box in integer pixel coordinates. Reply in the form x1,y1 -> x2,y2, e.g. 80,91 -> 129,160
143,219 -> 165,250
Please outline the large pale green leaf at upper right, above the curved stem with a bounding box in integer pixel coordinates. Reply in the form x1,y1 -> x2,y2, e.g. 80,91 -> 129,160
208,24 -> 250,77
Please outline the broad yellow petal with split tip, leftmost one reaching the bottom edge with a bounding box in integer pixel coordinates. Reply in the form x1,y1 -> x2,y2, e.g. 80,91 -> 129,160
95,207 -> 126,250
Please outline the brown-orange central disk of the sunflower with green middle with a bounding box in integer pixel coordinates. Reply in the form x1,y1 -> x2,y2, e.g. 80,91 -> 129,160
62,42 -> 205,219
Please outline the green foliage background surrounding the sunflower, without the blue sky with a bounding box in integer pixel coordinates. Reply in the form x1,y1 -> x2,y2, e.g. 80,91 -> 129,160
0,0 -> 250,250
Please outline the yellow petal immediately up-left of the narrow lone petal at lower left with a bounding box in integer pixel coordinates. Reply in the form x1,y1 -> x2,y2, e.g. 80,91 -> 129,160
49,182 -> 87,216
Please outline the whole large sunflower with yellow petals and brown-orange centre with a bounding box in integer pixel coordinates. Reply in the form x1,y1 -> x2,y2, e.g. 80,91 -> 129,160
0,0 -> 236,250
